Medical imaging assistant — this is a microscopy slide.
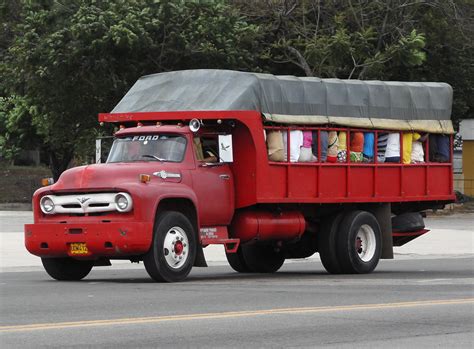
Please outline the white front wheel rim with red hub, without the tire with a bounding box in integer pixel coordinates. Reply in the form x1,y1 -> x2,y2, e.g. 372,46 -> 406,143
163,227 -> 189,269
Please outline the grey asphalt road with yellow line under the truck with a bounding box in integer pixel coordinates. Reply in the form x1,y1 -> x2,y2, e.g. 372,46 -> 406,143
0,257 -> 474,348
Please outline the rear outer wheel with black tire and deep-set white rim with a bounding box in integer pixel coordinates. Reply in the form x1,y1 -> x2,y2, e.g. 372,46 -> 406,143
336,211 -> 382,274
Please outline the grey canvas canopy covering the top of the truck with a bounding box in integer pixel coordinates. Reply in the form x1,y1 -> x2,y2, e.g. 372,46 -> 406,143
112,69 -> 453,133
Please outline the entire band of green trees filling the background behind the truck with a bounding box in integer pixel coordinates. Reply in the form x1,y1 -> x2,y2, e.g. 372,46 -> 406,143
0,0 -> 474,177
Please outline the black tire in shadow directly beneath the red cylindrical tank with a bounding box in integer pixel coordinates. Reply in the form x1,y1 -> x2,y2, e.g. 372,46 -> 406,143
242,244 -> 285,273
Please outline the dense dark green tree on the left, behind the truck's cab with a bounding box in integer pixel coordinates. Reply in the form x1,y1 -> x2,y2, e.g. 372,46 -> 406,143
0,0 -> 259,179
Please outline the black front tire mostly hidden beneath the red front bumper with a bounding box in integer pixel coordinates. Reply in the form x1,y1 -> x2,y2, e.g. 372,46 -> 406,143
41,257 -> 94,281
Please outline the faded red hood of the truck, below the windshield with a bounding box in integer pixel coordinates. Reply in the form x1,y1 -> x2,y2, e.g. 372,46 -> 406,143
51,162 -> 180,191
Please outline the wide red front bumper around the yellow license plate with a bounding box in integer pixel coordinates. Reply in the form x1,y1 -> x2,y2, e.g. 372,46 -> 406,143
25,222 -> 153,259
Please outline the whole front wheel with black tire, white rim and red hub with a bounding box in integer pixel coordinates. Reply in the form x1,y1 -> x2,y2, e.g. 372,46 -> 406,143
143,211 -> 196,282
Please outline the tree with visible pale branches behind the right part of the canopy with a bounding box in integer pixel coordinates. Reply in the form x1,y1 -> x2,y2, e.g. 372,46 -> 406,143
233,0 -> 474,123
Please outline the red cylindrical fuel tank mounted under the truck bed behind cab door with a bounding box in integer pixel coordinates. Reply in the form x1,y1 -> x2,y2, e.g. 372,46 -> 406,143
230,211 -> 306,243
